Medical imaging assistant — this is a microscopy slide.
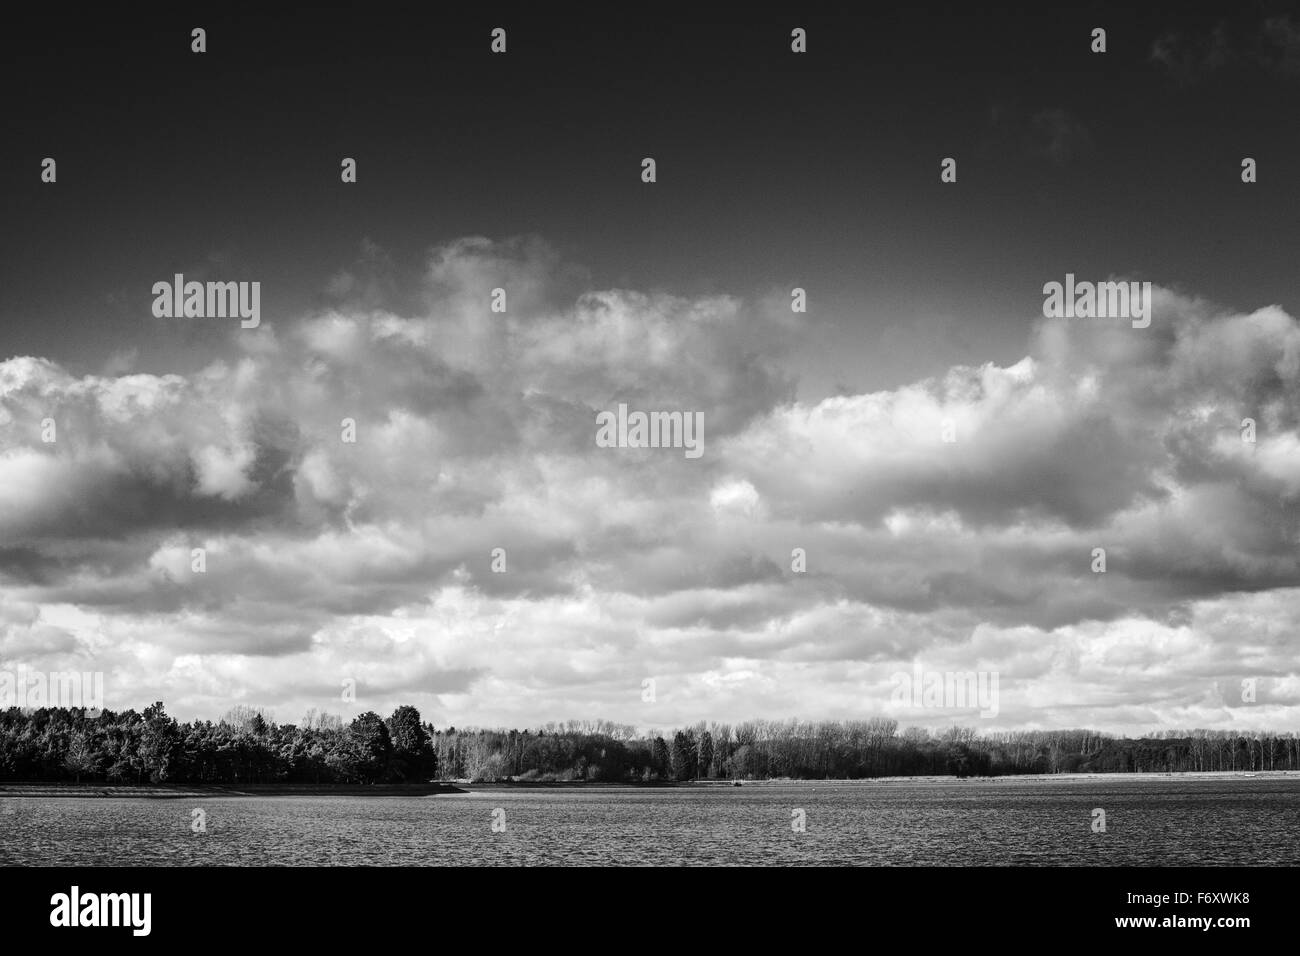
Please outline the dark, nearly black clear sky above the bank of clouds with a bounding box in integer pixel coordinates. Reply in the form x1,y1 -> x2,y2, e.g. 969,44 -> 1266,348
0,3 -> 1300,388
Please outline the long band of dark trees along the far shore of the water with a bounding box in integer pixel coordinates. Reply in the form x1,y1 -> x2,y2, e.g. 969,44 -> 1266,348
0,702 -> 1300,784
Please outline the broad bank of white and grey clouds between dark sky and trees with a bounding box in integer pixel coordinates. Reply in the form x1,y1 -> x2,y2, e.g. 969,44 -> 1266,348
0,238 -> 1300,730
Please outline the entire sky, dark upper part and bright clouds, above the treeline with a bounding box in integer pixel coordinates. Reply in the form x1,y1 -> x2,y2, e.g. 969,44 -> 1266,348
0,4 -> 1300,734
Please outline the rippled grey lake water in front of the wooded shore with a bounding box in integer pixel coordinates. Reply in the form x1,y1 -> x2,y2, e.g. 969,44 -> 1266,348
0,777 -> 1300,866
